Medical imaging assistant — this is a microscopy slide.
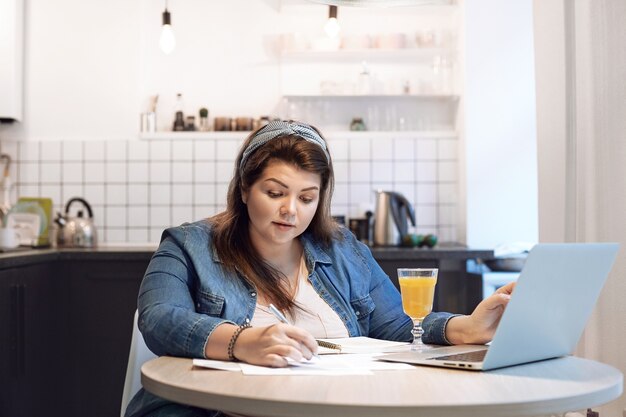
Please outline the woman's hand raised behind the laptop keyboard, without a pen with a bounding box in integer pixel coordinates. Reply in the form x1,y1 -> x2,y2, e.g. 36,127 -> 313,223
446,282 -> 515,345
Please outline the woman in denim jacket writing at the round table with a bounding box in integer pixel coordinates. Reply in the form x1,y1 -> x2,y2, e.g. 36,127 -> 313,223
127,121 -> 512,416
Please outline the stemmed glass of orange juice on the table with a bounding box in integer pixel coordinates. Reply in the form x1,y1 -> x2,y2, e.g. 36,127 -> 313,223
398,268 -> 439,350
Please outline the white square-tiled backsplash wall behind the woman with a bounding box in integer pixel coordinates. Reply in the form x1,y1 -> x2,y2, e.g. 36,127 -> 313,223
7,134 -> 460,243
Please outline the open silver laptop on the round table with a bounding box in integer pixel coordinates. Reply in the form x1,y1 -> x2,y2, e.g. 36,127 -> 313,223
378,243 -> 619,371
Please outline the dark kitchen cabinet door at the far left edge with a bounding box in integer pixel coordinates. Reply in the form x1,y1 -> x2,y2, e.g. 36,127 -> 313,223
0,262 -> 66,417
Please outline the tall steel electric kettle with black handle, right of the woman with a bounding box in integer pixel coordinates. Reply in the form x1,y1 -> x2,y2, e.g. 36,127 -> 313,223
374,190 -> 415,246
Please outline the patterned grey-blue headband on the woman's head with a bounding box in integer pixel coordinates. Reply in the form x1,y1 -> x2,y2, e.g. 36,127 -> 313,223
239,120 -> 330,171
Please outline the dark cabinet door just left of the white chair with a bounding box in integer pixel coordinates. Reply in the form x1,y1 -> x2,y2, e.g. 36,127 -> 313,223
64,260 -> 148,417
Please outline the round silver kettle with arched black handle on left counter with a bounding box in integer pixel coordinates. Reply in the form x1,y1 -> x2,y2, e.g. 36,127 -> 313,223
54,197 -> 98,248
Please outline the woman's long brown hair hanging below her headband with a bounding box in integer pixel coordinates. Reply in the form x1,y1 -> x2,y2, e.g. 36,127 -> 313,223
209,122 -> 338,314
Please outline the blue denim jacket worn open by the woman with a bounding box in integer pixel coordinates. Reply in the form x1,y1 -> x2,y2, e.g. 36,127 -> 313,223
125,220 -> 452,415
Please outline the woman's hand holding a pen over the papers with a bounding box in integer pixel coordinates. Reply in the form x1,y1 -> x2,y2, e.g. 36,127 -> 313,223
233,323 -> 317,368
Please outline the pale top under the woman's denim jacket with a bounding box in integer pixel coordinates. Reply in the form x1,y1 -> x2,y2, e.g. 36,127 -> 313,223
250,257 -> 350,339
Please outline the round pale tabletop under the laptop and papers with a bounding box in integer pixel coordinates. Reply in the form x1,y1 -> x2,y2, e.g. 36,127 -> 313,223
141,356 -> 623,417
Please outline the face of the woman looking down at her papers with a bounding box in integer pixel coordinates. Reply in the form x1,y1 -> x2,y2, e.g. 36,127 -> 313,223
242,161 -> 321,248
